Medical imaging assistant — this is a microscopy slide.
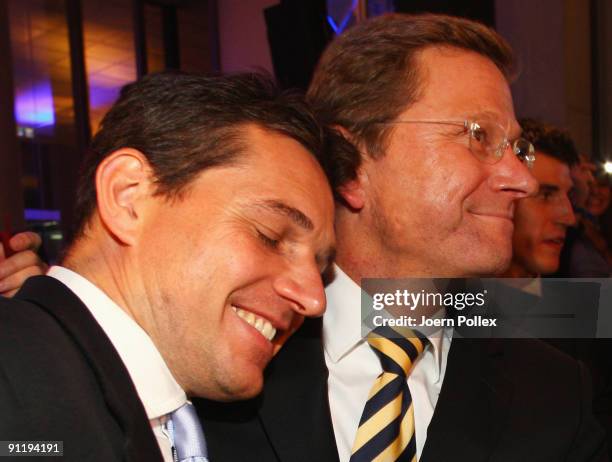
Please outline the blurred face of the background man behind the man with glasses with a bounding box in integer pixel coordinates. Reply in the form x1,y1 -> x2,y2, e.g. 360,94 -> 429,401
511,152 -> 576,277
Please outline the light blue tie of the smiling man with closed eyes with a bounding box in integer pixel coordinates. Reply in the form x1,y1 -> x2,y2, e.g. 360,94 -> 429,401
168,403 -> 209,462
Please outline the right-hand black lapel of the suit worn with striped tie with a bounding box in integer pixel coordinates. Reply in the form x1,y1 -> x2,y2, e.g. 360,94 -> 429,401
420,338 -> 512,462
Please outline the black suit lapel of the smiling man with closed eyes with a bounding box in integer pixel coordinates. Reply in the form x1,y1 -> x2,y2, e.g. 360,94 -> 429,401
16,276 -> 161,461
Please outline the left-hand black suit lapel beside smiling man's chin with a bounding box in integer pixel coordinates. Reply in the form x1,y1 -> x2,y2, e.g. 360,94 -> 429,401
259,319 -> 338,462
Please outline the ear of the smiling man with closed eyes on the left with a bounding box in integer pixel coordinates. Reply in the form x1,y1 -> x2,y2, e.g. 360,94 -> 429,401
96,148 -> 153,245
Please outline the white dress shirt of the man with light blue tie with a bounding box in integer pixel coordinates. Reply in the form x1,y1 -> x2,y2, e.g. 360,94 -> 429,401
47,266 -> 187,462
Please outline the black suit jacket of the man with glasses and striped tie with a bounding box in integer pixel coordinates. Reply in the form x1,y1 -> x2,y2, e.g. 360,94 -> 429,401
195,320 -> 607,462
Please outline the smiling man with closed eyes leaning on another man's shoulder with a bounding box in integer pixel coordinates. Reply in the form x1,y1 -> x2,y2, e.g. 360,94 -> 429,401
0,70 -> 334,462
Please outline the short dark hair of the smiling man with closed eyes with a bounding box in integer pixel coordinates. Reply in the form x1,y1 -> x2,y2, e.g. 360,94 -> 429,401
73,72 -> 351,239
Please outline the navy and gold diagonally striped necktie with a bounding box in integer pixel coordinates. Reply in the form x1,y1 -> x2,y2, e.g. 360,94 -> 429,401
350,327 -> 428,462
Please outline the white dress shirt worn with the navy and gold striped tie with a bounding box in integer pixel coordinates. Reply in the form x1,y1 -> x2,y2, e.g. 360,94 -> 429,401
323,266 -> 452,462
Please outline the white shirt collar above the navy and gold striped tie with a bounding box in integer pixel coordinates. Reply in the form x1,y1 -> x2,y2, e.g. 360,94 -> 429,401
323,265 -> 452,374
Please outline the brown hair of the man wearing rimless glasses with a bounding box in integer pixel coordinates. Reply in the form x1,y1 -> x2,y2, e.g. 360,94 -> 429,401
307,14 -> 514,181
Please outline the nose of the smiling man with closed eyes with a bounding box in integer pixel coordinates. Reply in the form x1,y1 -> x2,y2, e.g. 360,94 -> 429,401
274,260 -> 326,316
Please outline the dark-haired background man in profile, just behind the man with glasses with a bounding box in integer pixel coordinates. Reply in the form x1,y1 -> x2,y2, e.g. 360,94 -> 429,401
503,119 -> 612,452
